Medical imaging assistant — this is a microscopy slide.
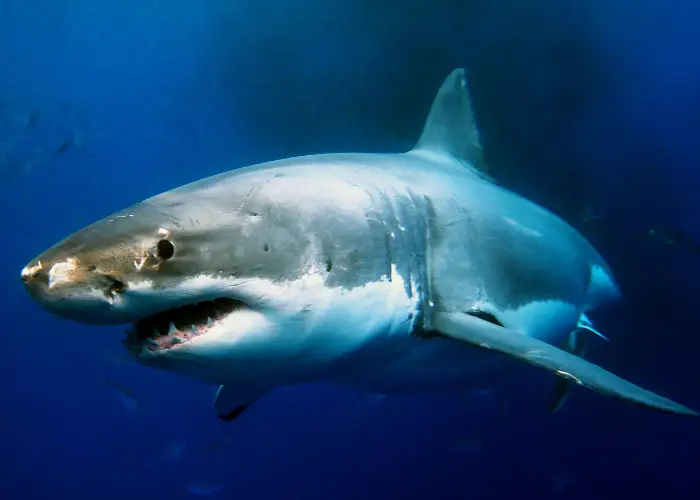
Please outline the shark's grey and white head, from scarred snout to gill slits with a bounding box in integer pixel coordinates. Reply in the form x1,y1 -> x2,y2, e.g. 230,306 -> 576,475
21,159 -> 416,383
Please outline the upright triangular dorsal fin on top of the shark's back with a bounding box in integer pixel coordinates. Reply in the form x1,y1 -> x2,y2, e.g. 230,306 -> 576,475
413,68 -> 486,173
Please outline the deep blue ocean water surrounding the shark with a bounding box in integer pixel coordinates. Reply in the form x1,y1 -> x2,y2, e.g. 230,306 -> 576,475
0,0 -> 700,500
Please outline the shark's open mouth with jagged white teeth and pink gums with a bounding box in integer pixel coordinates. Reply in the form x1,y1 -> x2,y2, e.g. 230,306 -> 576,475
123,298 -> 248,354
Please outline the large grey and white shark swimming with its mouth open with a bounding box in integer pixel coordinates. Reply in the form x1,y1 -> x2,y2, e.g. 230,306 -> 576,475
21,69 -> 696,420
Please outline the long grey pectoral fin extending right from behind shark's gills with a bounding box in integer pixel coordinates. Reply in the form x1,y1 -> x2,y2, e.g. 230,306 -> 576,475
434,313 -> 698,416
